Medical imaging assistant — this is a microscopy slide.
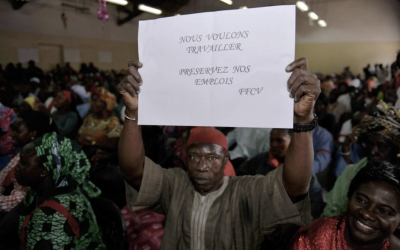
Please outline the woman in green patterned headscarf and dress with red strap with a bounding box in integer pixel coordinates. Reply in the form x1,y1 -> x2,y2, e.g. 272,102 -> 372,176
0,133 -> 105,249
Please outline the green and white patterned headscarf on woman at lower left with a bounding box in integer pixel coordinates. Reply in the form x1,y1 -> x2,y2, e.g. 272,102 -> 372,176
26,132 -> 101,203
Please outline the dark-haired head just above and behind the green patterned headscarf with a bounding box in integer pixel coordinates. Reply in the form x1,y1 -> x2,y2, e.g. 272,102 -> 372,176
11,111 -> 57,148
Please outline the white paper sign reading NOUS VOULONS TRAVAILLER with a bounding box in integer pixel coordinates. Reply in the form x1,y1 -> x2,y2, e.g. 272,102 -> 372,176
138,5 -> 296,128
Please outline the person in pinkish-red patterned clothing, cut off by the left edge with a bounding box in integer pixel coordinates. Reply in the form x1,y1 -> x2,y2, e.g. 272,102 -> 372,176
0,105 -> 16,170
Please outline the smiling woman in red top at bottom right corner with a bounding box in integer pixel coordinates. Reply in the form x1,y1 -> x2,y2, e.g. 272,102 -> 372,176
290,158 -> 400,250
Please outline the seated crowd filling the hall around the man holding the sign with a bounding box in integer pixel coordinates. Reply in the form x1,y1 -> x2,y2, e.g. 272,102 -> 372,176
0,53 -> 400,250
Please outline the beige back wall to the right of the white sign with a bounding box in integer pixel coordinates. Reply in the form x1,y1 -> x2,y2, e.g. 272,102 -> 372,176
296,0 -> 400,74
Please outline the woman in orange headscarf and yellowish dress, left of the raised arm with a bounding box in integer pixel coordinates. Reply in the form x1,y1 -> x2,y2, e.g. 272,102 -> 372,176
78,88 -> 122,167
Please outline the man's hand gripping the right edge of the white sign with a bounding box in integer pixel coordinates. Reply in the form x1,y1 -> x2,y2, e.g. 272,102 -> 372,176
286,58 -> 321,123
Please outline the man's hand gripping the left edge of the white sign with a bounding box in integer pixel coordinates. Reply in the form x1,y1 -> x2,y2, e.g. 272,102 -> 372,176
117,61 -> 143,114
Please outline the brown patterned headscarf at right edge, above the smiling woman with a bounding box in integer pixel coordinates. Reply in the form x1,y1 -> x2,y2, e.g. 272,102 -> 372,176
353,101 -> 400,149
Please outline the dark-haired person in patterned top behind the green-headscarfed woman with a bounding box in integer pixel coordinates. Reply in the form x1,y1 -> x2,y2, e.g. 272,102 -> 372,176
0,111 -> 57,218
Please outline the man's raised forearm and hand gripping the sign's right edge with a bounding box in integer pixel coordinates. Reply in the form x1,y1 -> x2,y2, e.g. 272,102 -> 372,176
282,58 -> 321,202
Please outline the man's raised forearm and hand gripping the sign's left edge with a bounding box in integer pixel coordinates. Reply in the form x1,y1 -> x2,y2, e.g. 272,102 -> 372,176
118,62 -> 145,190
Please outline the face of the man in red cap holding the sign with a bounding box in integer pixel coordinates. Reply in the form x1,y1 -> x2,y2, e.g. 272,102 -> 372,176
188,143 -> 228,195
